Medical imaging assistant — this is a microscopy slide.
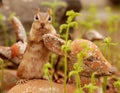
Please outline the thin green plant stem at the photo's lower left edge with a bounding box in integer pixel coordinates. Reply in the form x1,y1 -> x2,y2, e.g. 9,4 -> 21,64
0,58 -> 4,93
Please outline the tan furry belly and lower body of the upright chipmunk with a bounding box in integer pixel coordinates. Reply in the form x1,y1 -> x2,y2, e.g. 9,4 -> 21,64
18,42 -> 50,79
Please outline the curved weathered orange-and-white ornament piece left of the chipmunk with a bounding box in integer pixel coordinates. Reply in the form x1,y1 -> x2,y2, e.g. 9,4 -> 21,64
0,16 -> 27,65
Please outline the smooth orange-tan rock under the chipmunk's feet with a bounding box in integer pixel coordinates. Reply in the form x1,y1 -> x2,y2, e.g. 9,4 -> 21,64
8,79 -> 75,93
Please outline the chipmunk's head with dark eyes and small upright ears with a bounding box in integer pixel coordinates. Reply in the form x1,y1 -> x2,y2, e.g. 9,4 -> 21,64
33,9 -> 52,30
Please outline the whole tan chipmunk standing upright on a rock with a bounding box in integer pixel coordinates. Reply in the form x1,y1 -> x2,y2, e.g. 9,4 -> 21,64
17,9 -> 56,79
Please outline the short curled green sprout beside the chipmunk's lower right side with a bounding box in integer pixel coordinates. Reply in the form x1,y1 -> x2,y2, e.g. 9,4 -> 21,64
43,63 -> 53,93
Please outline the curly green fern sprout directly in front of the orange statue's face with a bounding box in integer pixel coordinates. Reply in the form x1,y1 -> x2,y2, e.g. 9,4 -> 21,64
69,43 -> 90,93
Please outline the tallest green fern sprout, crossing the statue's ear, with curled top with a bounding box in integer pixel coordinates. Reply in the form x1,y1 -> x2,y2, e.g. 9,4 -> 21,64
60,10 -> 80,93
